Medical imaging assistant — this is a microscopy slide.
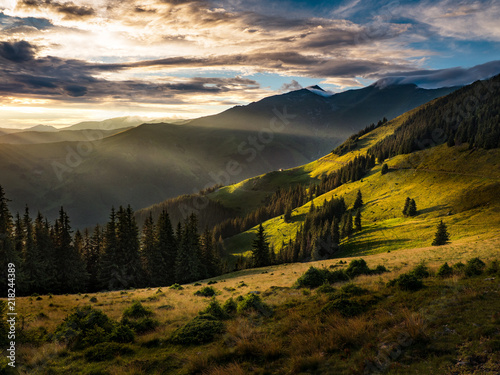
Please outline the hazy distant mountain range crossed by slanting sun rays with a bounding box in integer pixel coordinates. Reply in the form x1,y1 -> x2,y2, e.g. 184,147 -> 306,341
0,85 -> 456,227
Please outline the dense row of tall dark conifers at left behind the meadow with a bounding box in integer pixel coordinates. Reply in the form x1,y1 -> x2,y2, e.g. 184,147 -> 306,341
0,186 -> 226,295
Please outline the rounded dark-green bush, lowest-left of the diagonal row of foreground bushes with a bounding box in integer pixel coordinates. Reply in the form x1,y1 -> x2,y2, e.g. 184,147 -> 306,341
170,315 -> 224,345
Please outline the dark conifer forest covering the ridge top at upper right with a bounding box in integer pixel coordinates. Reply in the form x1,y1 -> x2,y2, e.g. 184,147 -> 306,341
368,75 -> 500,163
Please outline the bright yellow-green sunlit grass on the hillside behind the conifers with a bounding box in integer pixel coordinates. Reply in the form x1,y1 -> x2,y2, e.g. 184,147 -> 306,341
226,106 -> 500,256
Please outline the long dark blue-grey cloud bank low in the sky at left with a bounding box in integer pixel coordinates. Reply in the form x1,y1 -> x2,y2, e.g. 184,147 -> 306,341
0,41 -> 260,103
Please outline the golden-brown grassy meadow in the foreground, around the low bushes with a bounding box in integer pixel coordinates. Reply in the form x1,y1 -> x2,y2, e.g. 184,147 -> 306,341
16,237 -> 500,375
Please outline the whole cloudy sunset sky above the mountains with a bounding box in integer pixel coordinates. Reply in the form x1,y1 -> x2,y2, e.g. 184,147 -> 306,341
0,0 -> 500,128
